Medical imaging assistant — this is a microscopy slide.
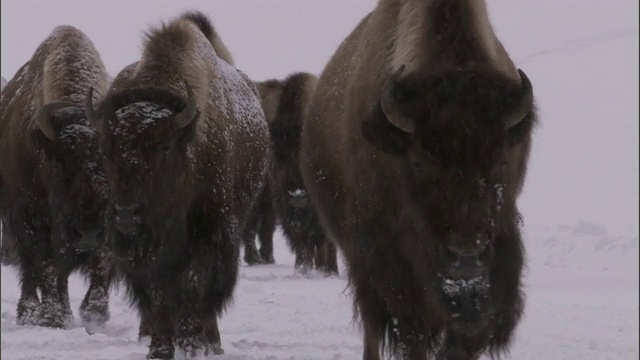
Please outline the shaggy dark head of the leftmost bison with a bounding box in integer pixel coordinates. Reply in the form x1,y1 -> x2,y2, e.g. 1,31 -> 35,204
34,102 -> 107,251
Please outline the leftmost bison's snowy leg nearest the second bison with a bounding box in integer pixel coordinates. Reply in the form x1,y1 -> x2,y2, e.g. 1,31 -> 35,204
80,251 -> 112,331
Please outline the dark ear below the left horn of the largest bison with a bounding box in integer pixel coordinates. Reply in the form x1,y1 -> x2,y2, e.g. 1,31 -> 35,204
362,105 -> 411,156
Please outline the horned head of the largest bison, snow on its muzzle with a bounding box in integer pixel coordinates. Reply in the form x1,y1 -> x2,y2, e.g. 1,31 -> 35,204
362,67 -> 535,280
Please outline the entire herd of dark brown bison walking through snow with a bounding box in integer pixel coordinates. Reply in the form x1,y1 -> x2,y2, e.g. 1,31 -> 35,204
0,0 -> 537,360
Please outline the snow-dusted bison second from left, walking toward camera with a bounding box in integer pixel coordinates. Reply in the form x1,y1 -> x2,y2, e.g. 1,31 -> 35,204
88,13 -> 271,359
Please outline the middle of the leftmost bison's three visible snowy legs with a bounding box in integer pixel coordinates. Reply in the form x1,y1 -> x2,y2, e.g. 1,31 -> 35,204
38,259 -> 65,328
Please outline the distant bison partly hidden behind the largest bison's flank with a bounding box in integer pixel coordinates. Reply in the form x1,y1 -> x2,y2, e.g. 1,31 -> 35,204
256,72 -> 338,275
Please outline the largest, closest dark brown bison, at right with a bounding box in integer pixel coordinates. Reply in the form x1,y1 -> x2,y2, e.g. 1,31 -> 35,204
301,0 -> 536,360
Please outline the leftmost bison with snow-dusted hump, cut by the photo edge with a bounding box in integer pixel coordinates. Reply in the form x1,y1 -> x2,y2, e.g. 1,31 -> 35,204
0,26 -> 113,327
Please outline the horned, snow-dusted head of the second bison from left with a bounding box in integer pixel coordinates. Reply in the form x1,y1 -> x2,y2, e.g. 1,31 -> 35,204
87,83 -> 199,256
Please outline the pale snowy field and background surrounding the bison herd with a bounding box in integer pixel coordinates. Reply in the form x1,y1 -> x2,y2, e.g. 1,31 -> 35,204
0,0 -> 639,360
